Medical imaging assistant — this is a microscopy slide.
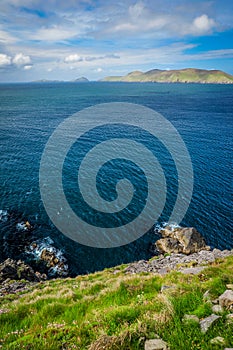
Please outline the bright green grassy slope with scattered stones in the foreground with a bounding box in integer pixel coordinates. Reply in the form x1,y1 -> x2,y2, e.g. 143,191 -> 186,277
0,257 -> 233,350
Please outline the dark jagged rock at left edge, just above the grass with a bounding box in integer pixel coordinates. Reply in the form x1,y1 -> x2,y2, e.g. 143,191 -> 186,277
0,259 -> 45,283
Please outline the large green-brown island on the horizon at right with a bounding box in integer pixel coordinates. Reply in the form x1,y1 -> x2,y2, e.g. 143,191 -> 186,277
101,68 -> 233,84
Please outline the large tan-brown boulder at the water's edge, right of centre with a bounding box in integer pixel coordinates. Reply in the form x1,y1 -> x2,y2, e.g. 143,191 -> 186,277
156,226 -> 210,255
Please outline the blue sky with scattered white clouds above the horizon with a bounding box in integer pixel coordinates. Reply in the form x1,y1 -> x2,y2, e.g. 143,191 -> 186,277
0,0 -> 233,82
